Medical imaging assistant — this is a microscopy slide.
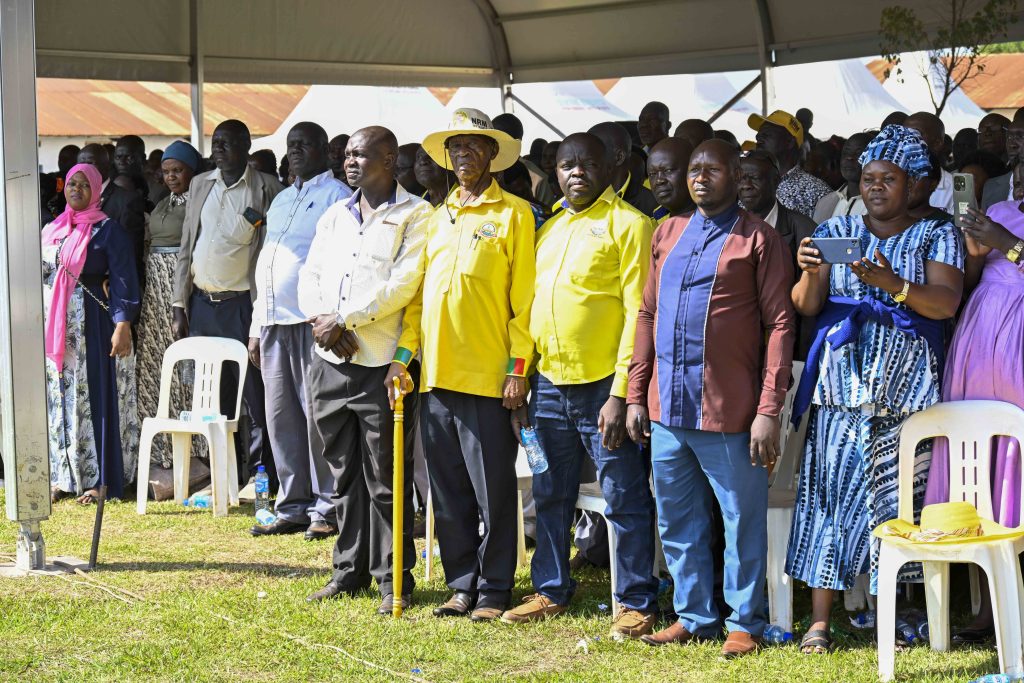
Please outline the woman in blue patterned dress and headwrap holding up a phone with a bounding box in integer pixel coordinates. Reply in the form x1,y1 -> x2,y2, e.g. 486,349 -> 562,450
785,126 -> 964,653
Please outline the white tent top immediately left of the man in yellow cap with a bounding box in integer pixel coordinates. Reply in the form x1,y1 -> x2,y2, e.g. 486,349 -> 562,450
606,72 -> 761,140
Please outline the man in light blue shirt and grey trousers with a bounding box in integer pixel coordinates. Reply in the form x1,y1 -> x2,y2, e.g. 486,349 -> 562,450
249,122 -> 352,541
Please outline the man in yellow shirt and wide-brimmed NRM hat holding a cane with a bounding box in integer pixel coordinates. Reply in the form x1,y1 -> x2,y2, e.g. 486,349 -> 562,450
388,109 -> 536,622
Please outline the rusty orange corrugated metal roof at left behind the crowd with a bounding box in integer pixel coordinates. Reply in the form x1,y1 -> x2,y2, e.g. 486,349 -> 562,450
36,78 -> 309,137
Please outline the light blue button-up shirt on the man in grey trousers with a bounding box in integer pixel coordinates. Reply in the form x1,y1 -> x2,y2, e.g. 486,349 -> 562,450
249,170 -> 352,337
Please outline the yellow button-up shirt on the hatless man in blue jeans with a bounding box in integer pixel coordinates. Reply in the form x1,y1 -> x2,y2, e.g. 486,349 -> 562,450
529,187 -> 654,398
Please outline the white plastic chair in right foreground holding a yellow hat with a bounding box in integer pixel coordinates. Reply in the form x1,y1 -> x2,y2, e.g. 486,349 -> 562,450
878,400 -> 1024,681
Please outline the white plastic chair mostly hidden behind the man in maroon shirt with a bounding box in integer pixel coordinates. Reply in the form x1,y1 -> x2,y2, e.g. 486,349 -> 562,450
767,360 -> 809,632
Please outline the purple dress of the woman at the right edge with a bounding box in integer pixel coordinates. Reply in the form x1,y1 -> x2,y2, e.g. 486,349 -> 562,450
925,201 -> 1024,527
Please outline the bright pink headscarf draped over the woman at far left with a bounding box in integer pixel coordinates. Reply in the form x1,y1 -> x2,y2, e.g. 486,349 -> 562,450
42,164 -> 106,371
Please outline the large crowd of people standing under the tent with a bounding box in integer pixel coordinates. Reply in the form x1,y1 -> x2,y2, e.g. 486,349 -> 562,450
36,94 -> 1024,657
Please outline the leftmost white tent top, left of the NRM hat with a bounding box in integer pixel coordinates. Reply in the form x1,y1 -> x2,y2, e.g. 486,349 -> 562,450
253,85 -> 446,157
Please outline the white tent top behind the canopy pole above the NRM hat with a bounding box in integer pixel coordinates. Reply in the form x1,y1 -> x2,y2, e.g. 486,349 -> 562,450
446,81 -> 635,144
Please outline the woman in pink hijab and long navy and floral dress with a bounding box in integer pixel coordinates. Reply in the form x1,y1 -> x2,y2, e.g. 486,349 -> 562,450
42,164 -> 139,504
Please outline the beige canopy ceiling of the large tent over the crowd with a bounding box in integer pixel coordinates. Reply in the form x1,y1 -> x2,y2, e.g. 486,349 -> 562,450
35,0 -> 1024,86
